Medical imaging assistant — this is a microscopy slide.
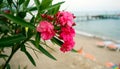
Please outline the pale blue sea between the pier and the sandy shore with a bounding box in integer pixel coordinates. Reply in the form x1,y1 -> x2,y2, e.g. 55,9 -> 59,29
75,11 -> 120,41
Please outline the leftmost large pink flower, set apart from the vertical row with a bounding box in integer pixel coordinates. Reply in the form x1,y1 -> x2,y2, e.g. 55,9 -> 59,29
37,21 -> 55,40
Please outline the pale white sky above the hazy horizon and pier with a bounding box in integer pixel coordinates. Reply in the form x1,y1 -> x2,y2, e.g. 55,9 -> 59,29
54,0 -> 120,11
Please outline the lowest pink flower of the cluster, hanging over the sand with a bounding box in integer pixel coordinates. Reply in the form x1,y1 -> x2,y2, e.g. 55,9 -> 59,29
60,40 -> 75,53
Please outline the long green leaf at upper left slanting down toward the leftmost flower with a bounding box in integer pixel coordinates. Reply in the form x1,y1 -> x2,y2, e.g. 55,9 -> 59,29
2,13 -> 35,29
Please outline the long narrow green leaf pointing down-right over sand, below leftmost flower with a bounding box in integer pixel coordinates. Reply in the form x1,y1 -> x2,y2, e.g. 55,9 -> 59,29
31,40 -> 56,60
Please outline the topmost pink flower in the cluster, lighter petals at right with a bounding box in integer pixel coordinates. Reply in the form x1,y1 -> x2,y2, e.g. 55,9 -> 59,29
56,11 -> 75,27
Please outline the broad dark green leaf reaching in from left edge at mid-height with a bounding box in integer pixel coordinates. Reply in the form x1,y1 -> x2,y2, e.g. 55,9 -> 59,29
0,34 -> 26,48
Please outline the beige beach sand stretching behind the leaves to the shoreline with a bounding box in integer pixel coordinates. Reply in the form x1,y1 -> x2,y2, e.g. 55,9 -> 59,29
0,34 -> 120,69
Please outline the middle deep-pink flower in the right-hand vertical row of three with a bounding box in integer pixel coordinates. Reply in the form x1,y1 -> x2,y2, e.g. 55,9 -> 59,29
60,27 -> 75,41
